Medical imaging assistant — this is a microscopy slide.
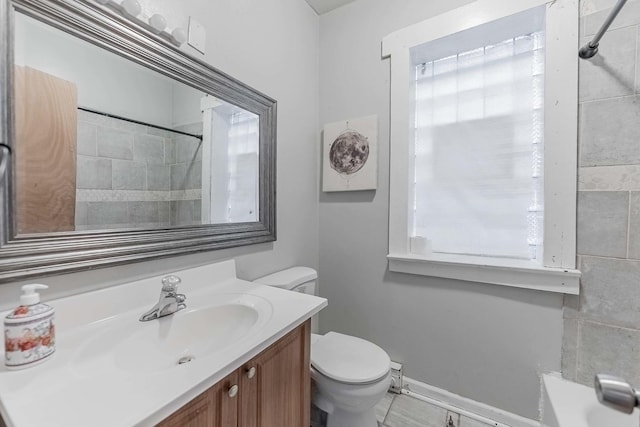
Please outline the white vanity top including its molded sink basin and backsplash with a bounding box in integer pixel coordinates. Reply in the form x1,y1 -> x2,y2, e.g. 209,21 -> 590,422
0,260 -> 328,427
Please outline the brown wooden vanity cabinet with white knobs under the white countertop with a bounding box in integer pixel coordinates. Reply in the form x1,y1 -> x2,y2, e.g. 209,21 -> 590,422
158,321 -> 311,427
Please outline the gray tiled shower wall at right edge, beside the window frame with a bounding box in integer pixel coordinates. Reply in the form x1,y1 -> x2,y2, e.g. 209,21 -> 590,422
562,0 -> 640,386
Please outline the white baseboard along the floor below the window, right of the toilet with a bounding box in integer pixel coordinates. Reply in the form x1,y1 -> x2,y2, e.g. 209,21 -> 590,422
402,377 -> 540,427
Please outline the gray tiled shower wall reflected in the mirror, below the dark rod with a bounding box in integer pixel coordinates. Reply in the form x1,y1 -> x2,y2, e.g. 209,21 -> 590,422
76,111 -> 202,230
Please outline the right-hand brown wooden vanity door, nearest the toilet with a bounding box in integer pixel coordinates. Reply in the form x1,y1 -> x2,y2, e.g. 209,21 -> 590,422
240,321 -> 311,427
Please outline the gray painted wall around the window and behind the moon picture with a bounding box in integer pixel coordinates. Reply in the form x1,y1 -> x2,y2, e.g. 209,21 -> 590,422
317,0 -> 562,418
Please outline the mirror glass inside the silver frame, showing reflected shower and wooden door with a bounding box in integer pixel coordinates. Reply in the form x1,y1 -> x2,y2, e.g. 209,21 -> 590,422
14,13 -> 259,235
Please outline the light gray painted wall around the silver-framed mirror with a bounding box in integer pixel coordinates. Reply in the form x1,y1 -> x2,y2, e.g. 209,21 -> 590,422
0,0 -> 319,310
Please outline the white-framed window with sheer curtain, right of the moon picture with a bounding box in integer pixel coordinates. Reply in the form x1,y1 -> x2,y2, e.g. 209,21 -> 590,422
383,0 -> 579,293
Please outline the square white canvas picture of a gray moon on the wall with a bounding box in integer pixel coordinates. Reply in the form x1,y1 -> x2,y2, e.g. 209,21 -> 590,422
322,115 -> 378,192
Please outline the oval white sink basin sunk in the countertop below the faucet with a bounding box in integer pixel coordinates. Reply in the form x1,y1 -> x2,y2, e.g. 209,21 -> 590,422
72,294 -> 271,376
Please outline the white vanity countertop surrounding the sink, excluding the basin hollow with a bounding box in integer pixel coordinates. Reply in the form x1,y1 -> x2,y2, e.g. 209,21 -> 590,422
0,261 -> 327,427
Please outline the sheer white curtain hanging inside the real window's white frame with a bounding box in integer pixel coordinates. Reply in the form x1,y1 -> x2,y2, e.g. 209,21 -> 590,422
409,32 -> 545,259
